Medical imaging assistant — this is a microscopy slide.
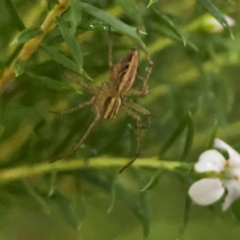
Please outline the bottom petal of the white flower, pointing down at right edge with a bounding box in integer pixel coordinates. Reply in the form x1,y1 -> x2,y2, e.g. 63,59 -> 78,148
222,180 -> 240,211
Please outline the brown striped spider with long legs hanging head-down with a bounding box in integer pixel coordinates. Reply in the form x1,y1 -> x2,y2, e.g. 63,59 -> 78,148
49,32 -> 153,173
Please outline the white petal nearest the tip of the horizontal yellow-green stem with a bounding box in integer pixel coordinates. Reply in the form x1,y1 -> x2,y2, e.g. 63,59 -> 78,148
195,149 -> 226,172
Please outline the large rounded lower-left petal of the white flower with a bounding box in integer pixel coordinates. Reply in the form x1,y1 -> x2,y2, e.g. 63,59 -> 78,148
188,178 -> 224,205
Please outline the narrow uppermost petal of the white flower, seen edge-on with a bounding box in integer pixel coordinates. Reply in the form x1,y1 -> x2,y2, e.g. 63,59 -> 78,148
214,138 -> 240,165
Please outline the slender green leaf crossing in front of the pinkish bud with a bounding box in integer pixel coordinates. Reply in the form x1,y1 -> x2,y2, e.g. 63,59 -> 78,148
197,0 -> 234,39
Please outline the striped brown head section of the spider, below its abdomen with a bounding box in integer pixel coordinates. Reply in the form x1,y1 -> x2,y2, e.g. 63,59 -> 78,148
101,96 -> 122,119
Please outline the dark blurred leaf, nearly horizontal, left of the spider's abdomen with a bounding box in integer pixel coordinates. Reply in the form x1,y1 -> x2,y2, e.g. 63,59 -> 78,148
26,72 -> 76,92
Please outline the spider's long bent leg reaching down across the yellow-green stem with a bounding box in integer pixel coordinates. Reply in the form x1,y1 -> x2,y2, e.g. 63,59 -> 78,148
119,106 -> 142,173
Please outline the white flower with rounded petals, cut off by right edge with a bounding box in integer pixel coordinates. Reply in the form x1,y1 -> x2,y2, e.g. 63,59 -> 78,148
188,138 -> 240,211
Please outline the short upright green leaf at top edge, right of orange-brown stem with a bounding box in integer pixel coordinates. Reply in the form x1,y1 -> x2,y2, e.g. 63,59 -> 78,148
70,0 -> 82,35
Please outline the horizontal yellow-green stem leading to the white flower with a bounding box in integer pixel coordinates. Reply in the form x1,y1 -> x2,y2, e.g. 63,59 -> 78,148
0,158 -> 190,183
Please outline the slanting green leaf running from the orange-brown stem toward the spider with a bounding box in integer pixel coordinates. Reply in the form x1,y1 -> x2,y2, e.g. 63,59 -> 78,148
57,17 -> 83,69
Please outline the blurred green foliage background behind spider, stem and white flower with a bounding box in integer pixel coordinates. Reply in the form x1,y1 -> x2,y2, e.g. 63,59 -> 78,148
0,0 -> 240,240
